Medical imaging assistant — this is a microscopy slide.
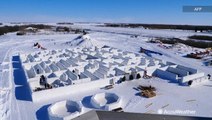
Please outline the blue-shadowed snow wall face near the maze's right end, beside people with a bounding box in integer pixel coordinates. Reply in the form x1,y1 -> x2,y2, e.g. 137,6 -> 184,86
154,69 -> 178,82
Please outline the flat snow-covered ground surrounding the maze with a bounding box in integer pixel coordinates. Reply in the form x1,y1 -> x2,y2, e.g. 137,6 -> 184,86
0,25 -> 212,120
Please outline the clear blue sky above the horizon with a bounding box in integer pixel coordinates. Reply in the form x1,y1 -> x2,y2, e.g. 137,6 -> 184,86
0,0 -> 212,25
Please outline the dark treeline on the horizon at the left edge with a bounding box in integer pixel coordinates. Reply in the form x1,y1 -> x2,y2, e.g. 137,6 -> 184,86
0,24 -> 52,35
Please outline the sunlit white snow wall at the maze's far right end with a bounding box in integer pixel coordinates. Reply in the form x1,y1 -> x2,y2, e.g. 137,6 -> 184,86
180,72 -> 205,83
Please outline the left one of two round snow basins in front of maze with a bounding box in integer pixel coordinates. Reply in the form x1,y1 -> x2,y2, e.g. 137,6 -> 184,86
48,100 -> 83,120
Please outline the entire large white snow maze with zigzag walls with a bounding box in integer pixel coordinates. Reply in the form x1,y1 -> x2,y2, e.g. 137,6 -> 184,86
20,47 -> 205,103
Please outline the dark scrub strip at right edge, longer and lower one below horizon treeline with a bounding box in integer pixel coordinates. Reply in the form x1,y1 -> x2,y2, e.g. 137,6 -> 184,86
158,38 -> 212,48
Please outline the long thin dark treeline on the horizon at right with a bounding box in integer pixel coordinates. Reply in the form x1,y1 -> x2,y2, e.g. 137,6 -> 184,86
105,23 -> 212,32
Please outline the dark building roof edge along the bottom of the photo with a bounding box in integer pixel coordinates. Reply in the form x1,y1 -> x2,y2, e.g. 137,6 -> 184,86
73,111 -> 211,120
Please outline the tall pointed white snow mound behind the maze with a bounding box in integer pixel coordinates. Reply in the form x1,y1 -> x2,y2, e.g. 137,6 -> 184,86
65,35 -> 94,48
